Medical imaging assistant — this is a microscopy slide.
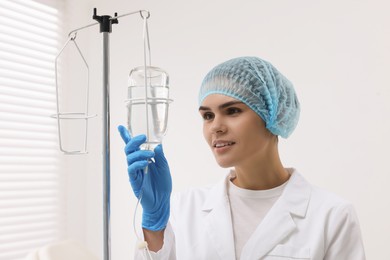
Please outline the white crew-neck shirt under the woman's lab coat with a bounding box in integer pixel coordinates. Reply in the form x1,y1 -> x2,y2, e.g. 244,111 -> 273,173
228,177 -> 287,259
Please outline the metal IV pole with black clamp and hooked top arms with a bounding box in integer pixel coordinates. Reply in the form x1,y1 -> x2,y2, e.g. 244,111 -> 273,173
57,8 -> 150,260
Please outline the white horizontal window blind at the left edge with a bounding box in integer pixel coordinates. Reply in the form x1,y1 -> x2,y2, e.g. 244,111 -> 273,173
0,0 -> 65,260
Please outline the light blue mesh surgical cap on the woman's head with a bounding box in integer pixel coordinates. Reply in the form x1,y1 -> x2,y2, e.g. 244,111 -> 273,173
199,57 -> 300,138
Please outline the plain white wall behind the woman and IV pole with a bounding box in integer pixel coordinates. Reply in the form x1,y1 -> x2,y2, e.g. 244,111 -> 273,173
64,0 -> 390,259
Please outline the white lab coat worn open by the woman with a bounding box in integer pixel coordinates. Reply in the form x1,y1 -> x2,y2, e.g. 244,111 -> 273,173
136,170 -> 365,260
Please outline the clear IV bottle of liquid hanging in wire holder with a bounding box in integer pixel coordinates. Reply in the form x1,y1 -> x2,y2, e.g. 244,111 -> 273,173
127,66 -> 172,150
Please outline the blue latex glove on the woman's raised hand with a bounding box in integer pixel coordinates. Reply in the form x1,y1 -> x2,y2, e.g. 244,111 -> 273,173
118,126 -> 172,231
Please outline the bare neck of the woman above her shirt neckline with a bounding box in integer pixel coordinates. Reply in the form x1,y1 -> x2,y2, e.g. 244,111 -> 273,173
233,146 -> 290,190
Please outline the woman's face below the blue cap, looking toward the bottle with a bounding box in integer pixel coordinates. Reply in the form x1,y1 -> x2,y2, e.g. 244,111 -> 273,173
199,94 -> 277,167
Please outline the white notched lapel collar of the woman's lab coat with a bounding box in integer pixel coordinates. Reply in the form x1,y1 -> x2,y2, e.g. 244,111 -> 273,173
202,169 -> 311,259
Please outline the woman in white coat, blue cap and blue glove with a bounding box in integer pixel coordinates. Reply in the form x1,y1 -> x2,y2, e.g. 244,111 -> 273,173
119,57 -> 365,260
